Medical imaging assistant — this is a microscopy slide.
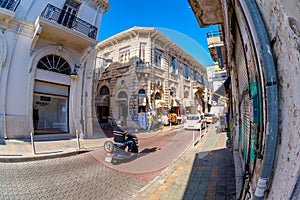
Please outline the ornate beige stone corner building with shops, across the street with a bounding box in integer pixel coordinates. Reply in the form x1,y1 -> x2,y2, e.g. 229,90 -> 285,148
95,27 -> 207,127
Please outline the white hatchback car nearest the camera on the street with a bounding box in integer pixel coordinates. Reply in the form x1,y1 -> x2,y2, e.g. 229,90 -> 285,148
183,114 -> 206,130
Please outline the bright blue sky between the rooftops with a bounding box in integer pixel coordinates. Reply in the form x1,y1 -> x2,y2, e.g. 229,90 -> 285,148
98,0 -> 217,66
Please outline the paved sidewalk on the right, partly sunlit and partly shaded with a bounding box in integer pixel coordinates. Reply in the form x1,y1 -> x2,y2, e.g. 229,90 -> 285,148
134,124 -> 236,200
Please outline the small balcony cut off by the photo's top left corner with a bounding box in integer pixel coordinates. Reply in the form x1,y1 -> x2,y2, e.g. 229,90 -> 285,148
0,0 -> 21,24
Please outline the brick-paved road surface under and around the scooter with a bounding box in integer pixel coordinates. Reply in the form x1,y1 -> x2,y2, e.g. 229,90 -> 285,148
0,127 -> 196,199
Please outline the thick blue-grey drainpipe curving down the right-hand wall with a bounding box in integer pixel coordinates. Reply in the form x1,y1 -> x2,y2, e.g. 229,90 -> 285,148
239,0 -> 279,200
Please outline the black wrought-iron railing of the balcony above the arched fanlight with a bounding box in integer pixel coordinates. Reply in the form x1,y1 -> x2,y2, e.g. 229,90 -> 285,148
41,4 -> 98,39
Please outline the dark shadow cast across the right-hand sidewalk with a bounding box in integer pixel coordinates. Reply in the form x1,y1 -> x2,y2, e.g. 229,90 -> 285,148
183,149 -> 236,199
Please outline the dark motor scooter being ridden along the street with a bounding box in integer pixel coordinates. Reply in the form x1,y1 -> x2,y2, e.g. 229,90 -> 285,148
104,130 -> 139,164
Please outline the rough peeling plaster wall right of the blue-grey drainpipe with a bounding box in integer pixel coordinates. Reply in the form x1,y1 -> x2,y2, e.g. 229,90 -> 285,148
257,0 -> 300,199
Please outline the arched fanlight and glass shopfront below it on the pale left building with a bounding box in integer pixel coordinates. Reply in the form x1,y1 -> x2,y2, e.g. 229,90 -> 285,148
32,54 -> 71,134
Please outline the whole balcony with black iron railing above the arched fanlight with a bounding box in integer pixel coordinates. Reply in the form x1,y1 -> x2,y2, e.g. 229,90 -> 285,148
36,4 -> 98,49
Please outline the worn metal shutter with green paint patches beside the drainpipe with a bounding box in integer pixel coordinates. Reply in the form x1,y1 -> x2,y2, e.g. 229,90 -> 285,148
234,19 -> 262,170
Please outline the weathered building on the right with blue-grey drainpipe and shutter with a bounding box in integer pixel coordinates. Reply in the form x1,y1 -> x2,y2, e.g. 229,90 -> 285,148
189,0 -> 300,199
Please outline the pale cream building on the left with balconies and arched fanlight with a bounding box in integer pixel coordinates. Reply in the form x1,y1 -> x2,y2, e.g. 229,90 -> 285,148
0,0 -> 108,139
